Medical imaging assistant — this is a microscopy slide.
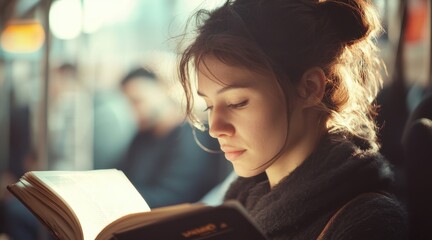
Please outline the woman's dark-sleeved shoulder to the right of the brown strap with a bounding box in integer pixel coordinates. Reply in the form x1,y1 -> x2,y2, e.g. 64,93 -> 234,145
325,194 -> 408,240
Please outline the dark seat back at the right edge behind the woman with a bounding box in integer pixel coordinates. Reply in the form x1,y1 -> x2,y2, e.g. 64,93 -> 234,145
402,95 -> 432,240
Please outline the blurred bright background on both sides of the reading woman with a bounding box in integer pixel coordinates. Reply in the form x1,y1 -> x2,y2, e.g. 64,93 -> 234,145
0,0 -> 431,239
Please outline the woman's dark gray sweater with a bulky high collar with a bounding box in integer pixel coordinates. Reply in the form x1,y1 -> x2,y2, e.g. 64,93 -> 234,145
225,135 -> 408,240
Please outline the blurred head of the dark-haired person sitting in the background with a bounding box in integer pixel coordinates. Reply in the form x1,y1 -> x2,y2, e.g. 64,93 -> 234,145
120,68 -> 170,131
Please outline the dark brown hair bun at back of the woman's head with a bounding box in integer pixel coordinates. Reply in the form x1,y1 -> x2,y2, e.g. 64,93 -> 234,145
319,0 -> 371,45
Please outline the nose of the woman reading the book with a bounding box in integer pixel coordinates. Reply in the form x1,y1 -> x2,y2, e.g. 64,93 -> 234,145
209,108 -> 235,138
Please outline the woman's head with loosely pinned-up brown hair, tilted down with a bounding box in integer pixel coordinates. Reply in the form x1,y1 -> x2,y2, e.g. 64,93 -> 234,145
180,0 -> 382,175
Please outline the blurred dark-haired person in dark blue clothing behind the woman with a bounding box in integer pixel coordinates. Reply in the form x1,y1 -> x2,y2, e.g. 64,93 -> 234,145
115,67 -> 229,208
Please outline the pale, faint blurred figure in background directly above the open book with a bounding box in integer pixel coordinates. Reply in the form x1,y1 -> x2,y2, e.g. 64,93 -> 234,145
48,62 -> 92,170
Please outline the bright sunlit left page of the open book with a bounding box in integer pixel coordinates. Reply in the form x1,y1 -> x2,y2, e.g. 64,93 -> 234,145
32,169 -> 150,240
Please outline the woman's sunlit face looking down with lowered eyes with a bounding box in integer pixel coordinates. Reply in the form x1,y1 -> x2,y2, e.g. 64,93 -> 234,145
198,57 -> 288,177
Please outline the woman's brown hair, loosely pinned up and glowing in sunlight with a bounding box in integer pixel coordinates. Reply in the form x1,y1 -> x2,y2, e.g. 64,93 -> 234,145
179,0 -> 384,143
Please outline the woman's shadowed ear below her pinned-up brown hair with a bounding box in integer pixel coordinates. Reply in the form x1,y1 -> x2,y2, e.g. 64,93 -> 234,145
297,67 -> 326,107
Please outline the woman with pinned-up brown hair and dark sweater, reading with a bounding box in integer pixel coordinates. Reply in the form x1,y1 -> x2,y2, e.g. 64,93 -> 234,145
180,0 -> 407,239
